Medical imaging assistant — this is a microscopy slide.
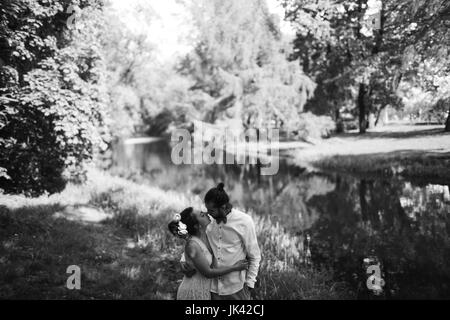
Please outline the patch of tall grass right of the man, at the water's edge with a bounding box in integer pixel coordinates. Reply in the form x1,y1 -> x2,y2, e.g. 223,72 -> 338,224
253,215 -> 353,300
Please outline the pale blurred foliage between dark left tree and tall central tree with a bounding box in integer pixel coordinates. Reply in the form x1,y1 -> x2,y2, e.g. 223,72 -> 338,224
101,2 -> 189,139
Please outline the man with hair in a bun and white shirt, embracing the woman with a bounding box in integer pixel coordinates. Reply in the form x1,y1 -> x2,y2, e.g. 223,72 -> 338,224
183,183 -> 261,300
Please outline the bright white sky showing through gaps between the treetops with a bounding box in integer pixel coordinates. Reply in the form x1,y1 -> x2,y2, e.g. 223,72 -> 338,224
110,0 -> 293,60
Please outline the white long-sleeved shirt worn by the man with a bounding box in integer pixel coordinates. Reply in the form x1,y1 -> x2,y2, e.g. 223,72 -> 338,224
206,209 -> 261,295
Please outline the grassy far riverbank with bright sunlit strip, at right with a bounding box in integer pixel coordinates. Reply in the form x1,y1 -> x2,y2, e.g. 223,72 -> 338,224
289,125 -> 450,182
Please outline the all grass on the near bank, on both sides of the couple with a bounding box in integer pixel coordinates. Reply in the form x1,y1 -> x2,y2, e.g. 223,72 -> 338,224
0,170 -> 354,300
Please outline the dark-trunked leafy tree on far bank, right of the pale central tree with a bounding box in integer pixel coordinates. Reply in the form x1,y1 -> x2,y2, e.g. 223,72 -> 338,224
283,0 -> 392,133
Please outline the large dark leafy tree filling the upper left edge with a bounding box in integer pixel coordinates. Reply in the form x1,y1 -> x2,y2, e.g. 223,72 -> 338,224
0,0 -> 108,194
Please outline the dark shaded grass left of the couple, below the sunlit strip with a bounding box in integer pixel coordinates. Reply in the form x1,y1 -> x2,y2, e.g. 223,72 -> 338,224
0,205 -> 180,299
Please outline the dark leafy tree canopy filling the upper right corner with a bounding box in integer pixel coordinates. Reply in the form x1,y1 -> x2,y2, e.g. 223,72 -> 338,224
282,0 -> 449,133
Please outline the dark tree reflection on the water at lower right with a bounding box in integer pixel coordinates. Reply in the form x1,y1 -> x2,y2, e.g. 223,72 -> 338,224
308,175 -> 450,298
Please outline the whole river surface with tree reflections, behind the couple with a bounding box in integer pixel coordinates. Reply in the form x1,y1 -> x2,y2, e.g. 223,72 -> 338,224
112,143 -> 450,299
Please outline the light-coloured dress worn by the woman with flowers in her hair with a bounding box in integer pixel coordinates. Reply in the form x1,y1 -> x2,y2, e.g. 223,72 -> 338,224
177,237 -> 213,300
